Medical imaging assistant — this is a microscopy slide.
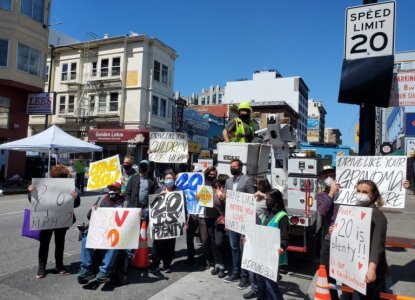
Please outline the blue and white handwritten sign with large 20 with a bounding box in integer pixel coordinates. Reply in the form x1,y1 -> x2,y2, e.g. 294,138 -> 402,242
175,173 -> 205,214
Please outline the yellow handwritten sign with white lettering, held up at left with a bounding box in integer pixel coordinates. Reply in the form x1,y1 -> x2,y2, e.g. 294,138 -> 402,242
86,155 -> 121,191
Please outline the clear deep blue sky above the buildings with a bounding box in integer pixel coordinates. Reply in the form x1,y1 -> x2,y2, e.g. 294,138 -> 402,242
50,0 -> 415,149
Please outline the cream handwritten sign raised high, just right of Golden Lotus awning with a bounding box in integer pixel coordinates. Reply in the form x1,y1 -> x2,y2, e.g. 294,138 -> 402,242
149,132 -> 189,163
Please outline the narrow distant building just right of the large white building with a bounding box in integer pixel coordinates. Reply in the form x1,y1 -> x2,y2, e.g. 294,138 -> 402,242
307,99 -> 327,143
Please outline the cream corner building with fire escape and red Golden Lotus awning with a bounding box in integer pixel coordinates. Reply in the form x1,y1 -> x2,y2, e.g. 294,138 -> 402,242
30,33 -> 177,160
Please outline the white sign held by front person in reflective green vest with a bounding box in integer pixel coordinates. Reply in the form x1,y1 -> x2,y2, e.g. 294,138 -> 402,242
241,225 -> 280,282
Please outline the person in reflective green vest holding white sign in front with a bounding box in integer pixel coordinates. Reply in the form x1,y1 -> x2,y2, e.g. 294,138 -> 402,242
256,190 -> 289,300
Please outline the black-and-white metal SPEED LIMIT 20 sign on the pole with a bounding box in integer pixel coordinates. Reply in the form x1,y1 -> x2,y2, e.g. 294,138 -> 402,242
344,1 -> 395,60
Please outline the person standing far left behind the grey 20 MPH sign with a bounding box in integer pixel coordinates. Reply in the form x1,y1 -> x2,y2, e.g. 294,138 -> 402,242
28,164 -> 81,279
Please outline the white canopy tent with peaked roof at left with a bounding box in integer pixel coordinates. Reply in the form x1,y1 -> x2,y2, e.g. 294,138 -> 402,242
0,125 -> 102,172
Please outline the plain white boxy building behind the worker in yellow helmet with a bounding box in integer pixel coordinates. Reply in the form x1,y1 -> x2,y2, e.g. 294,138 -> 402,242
222,70 -> 309,142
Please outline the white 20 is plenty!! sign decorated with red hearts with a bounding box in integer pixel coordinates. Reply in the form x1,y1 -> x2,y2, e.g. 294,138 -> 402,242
329,205 -> 372,295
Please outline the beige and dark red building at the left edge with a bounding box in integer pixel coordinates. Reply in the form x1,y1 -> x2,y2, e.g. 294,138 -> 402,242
0,0 -> 51,177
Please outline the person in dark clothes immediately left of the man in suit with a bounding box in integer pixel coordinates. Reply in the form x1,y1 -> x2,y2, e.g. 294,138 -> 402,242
208,174 -> 229,278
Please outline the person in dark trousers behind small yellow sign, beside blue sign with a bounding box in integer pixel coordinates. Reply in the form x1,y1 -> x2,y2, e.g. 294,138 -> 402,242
186,166 -> 217,268
